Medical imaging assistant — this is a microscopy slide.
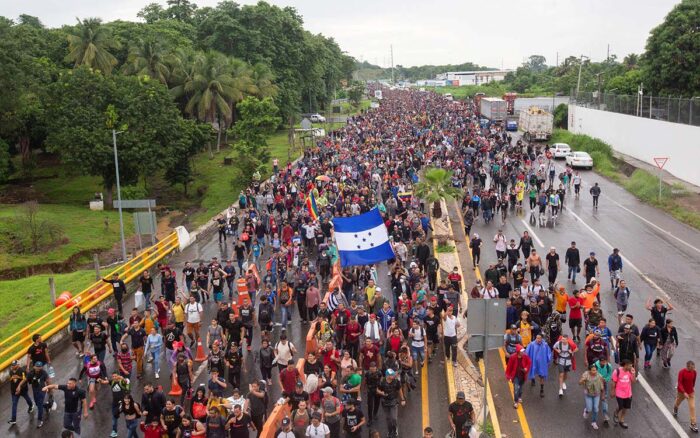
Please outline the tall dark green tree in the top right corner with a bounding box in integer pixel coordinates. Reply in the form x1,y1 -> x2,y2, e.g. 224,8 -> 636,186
642,0 -> 700,97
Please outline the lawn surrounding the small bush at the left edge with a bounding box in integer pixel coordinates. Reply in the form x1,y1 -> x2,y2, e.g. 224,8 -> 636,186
0,204 -> 133,273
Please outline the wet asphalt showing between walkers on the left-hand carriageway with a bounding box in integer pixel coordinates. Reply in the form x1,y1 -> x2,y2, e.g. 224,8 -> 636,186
0,224 -> 449,437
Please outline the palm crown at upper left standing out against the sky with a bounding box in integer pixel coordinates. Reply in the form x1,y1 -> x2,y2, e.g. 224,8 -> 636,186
66,18 -> 119,74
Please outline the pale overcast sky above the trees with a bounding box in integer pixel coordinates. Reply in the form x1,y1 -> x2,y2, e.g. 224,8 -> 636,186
0,0 -> 679,68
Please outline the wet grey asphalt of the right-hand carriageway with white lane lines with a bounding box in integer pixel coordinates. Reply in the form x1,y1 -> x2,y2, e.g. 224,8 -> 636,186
450,143 -> 700,437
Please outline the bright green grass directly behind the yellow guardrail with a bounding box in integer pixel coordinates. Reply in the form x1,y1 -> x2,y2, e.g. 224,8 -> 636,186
0,271 -> 95,339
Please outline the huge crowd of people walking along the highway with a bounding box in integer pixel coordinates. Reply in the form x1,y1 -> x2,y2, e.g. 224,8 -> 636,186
6,86 -> 695,438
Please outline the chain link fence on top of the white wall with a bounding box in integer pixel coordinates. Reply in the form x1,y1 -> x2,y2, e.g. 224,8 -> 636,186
571,92 -> 700,126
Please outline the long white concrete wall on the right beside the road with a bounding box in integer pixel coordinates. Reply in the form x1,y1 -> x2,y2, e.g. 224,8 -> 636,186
569,105 -> 700,186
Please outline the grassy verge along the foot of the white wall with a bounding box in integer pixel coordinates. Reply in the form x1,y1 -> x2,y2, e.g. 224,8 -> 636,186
551,129 -> 700,229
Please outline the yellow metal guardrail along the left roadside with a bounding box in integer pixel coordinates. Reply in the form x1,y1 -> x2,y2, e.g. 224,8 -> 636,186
0,232 -> 180,371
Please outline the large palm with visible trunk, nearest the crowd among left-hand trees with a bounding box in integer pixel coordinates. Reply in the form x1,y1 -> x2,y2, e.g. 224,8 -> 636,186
171,51 -> 237,157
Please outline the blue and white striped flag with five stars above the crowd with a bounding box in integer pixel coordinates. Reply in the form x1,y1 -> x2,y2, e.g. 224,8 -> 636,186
333,208 -> 394,267
